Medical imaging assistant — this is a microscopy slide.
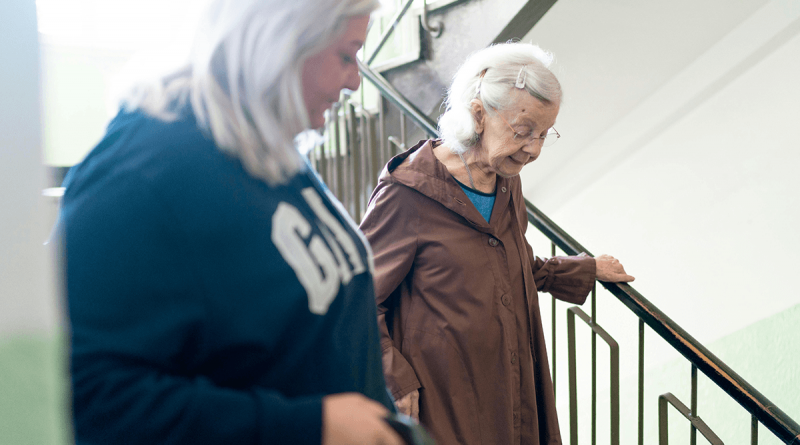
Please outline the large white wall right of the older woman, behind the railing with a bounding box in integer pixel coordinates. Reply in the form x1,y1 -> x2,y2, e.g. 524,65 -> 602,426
523,0 -> 800,443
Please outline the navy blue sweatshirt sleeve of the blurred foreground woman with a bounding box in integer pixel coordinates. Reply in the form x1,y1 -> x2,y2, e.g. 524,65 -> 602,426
61,168 -> 322,445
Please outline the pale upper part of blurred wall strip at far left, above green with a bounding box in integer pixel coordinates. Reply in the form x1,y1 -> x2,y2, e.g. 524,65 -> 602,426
0,0 -> 55,335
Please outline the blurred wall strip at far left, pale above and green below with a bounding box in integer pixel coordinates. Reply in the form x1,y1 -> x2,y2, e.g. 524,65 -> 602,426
0,0 -> 66,445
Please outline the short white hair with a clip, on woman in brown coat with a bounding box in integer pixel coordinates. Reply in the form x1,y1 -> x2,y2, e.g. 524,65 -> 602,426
439,43 -> 561,153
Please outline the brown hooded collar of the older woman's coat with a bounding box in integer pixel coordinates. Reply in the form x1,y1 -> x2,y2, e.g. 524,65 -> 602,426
380,139 -> 519,233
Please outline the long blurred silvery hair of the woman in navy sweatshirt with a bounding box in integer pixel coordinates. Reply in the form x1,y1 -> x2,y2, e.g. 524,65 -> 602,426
123,0 -> 379,185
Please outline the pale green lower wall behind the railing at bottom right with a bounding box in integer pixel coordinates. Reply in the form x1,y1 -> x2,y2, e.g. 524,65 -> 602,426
558,303 -> 800,445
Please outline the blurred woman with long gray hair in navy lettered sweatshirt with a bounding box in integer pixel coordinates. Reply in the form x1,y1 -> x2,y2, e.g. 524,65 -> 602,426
60,0 -> 401,445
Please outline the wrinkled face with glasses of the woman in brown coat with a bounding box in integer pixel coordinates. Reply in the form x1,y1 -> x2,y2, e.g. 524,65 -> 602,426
475,89 -> 559,178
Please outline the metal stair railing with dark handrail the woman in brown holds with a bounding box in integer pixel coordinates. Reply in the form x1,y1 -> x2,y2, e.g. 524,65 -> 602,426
310,44 -> 800,445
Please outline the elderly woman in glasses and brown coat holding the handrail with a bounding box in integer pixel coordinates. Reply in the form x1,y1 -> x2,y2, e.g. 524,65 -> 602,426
361,43 -> 633,445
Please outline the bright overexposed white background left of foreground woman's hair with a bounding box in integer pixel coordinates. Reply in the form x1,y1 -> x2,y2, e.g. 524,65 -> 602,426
36,0 -> 214,166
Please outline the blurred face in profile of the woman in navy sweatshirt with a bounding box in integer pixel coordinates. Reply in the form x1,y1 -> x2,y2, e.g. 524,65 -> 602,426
302,15 -> 369,128
